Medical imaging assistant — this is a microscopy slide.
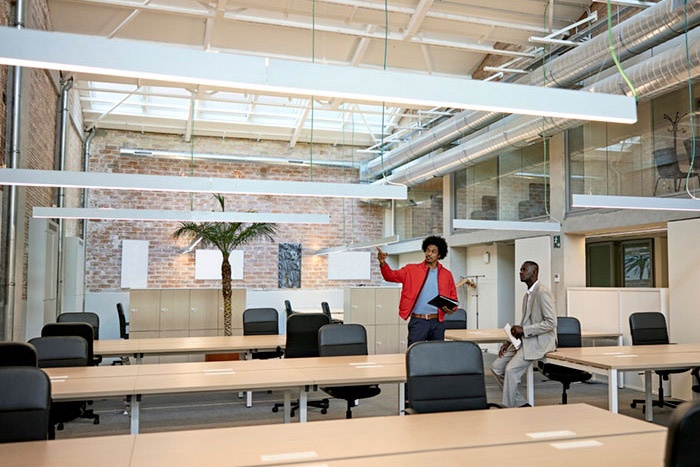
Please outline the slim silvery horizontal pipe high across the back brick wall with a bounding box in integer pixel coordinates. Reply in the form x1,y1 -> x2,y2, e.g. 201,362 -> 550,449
119,148 -> 360,169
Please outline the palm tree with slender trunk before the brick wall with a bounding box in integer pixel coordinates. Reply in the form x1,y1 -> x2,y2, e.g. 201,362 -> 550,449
173,194 -> 277,336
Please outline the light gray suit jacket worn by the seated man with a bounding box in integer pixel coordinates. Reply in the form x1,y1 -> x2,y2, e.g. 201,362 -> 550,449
520,282 -> 557,360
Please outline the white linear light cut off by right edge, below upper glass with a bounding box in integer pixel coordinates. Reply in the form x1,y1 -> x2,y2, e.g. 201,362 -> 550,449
571,195 -> 700,211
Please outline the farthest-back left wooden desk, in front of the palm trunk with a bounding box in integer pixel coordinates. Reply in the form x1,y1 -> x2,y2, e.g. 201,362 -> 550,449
94,334 -> 287,363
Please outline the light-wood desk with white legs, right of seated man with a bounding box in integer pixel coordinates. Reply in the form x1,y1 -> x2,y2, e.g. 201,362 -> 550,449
543,344 -> 700,421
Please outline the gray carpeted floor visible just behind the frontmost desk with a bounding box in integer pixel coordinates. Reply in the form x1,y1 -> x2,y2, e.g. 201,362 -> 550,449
56,354 -> 684,439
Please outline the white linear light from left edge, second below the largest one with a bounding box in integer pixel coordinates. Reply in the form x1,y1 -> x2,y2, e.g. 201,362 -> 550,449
0,169 -> 408,199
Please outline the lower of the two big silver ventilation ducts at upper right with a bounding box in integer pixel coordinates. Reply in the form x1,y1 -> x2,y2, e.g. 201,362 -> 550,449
380,28 -> 700,185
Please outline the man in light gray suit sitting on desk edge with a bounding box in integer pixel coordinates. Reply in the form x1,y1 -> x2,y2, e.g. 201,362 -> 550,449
491,261 -> 557,407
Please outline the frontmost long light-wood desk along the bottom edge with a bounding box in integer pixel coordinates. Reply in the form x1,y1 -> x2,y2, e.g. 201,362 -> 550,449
0,404 -> 666,467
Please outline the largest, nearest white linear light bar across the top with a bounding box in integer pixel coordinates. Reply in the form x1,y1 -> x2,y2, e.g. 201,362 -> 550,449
0,27 -> 637,123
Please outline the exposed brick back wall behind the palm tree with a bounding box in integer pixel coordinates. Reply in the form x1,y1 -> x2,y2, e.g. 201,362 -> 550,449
86,130 -> 383,292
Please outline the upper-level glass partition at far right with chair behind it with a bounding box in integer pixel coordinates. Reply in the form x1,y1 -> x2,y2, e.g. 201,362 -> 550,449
568,86 -> 700,201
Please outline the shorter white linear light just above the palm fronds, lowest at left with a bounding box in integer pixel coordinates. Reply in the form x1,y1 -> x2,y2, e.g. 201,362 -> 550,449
32,207 -> 331,224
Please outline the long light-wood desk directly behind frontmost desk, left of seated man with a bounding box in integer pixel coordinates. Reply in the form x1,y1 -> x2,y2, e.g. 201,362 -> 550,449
44,354 -> 406,433
